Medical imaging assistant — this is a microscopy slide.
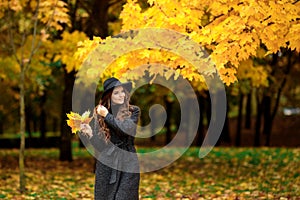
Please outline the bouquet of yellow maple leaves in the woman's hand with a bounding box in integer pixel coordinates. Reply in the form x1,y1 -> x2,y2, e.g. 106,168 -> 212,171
67,110 -> 93,133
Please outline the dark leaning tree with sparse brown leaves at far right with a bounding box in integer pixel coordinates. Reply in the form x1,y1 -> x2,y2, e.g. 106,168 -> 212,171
254,49 -> 300,146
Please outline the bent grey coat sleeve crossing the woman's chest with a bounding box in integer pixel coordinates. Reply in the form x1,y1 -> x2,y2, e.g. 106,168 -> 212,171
104,106 -> 140,136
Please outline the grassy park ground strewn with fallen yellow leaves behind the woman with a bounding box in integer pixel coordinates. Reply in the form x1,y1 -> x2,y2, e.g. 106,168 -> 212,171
0,147 -> 300,200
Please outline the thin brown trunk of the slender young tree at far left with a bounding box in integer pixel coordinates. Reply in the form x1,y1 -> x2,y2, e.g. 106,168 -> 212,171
19,66 -> 25,193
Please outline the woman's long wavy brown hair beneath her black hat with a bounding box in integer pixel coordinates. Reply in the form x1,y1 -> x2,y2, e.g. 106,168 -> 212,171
94,87 -> 131,142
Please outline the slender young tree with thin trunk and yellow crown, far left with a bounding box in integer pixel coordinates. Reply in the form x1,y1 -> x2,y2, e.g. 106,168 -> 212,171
0,0 -> 69,192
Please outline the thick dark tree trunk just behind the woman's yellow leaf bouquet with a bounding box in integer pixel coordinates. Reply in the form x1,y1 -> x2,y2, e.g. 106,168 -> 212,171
59,68 -> 75,161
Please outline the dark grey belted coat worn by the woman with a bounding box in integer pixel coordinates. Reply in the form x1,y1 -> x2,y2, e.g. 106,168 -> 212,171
90,106 -> 140,200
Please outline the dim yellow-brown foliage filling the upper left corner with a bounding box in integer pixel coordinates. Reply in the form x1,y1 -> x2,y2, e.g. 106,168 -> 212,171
0,0 -> 72,102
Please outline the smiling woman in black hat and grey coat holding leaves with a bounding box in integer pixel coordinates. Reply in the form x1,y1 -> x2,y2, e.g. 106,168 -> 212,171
81,77 -> 140,200
